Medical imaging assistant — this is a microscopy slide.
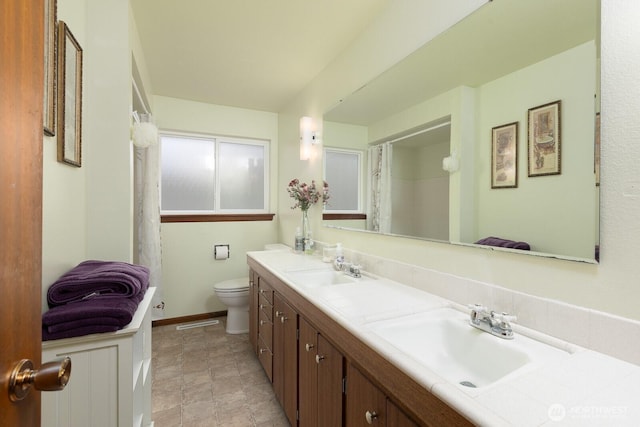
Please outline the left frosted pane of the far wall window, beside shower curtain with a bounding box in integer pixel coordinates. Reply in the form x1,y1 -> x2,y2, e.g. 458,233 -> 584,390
160,136 -> 215,211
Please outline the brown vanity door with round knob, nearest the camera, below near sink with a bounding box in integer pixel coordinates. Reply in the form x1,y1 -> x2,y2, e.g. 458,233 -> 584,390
346,364 -> 387,427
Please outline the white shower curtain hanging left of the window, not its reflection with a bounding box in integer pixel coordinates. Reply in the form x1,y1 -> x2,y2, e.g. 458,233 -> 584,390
133,115 -> 164,319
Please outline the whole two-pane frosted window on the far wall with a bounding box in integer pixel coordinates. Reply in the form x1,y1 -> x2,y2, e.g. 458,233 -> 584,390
160,134 -> 269,214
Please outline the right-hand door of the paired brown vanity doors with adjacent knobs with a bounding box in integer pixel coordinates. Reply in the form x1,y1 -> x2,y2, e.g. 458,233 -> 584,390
316,335 -> 344,427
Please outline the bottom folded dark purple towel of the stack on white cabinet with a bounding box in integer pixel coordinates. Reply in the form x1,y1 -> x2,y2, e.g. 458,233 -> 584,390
42,293 -> 144,341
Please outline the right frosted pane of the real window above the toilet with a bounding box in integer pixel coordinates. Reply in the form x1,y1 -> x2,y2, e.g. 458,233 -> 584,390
219,142 -> 265,210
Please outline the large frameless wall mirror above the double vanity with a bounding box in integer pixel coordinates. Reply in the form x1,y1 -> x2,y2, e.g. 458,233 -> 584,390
323,0 -> 600,262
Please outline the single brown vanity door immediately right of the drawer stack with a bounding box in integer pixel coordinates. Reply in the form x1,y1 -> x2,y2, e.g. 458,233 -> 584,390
273,293 -> 298,425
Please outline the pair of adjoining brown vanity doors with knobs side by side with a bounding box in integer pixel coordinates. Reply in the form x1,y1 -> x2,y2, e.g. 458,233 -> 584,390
298,317 -> 344,427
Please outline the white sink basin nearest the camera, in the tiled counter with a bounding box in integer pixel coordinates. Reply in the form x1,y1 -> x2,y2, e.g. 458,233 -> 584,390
369,308 -> 569,389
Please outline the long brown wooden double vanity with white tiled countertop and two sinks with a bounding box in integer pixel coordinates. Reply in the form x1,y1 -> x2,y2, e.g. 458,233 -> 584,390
247,250 -> 640,427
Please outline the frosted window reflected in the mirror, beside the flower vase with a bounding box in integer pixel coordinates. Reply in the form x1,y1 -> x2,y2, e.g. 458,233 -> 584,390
324,148 -> 362,213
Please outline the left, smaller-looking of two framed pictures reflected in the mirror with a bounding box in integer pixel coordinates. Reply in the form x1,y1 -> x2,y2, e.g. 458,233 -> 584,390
491,122 -> 518,188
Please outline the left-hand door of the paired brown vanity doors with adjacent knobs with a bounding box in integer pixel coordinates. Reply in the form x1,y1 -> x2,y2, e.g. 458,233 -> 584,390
298,317 -> 320,427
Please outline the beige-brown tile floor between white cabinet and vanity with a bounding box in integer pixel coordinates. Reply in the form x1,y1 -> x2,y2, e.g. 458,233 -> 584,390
152,318 -> 289,427
